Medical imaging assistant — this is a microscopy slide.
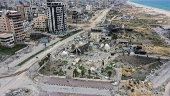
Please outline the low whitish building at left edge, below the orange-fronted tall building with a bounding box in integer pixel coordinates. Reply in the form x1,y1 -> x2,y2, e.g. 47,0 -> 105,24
0,32 -> 14,48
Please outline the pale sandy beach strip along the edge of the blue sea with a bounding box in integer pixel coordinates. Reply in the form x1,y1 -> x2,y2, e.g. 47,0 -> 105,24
127,1 -> 170,17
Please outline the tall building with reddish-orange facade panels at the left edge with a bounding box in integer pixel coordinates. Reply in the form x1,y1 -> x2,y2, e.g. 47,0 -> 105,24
0,10 -> 25,42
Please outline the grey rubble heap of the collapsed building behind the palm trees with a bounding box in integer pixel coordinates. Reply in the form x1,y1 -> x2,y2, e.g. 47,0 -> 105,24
46,35 -> 111,71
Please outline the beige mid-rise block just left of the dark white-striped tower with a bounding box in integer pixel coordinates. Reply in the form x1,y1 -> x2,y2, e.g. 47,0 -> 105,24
33,16 -> 48,32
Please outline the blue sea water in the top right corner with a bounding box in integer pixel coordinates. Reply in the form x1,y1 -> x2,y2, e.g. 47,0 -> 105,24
130,0 -> 170,11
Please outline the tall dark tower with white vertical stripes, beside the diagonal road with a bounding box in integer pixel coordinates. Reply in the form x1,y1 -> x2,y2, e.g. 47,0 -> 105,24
47,1 -> 67,34
